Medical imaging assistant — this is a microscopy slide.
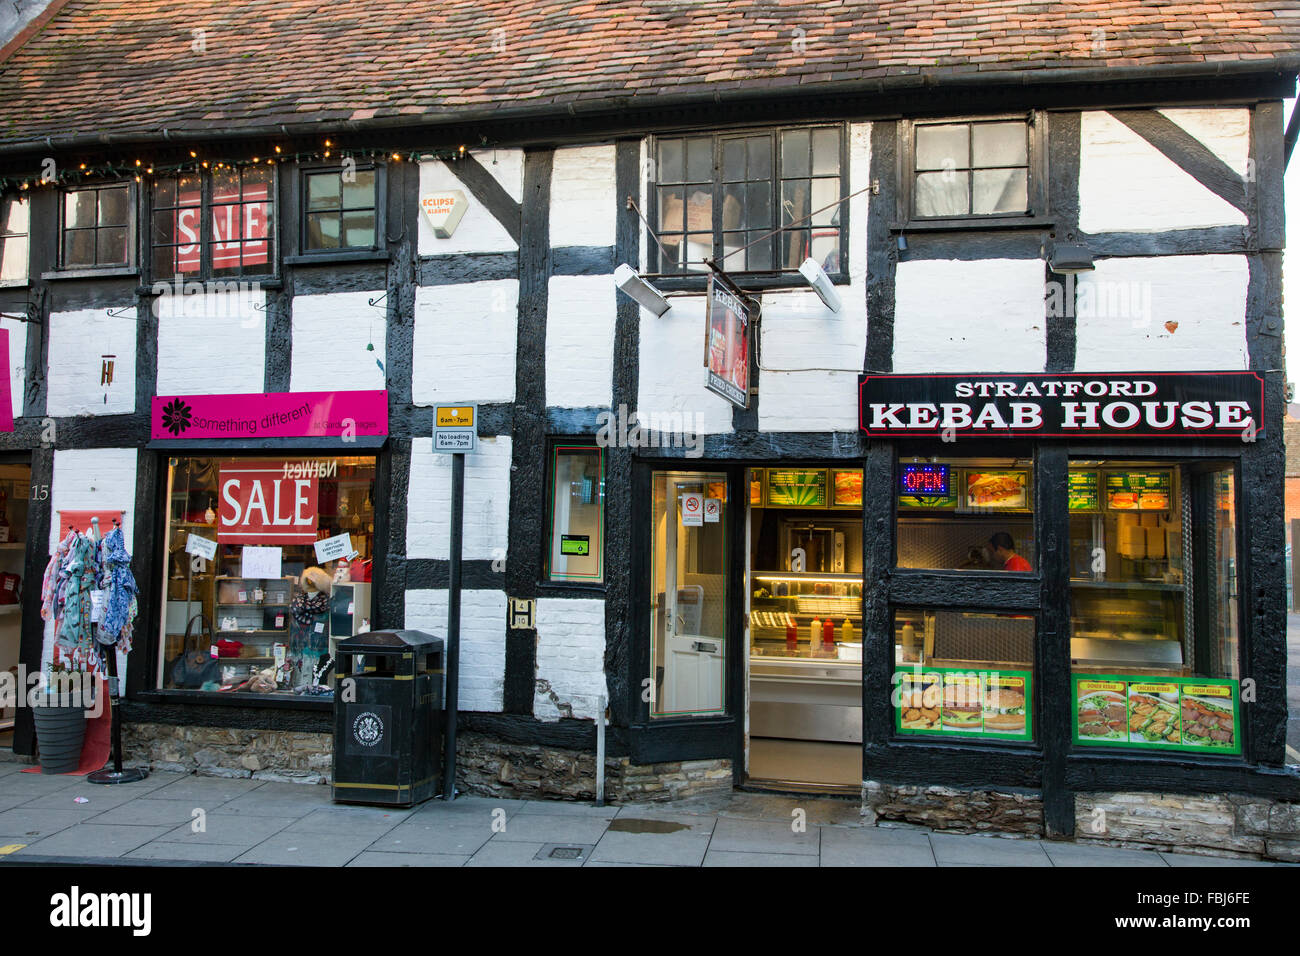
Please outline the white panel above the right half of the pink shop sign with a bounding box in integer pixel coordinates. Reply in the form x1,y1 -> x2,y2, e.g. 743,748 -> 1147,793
289,289 -> 387,392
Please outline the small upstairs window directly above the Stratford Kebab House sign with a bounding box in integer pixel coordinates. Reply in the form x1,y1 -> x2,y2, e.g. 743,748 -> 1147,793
909,118 -> 1037,220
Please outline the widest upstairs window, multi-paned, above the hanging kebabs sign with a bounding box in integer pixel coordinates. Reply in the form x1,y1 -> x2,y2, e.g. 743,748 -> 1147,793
651,126 -> 846,274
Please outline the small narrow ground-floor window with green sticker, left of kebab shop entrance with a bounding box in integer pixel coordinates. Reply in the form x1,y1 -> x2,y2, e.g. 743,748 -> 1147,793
546,442 -> 605,584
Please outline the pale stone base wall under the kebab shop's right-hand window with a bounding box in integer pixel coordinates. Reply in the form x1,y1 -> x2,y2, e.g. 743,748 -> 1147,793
1074,793 -> 1300,862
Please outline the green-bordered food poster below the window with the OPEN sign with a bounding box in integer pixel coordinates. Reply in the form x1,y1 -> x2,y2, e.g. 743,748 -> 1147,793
893,667 -> 1034,740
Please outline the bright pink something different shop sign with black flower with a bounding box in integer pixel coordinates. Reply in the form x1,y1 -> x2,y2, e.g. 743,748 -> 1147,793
150,390 -> 389,440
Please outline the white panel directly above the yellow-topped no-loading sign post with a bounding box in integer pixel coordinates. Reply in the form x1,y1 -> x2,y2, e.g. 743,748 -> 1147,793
411,278 -> 519,405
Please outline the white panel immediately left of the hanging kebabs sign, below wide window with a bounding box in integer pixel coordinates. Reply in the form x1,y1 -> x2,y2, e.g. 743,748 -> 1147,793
637,295 -> 733,434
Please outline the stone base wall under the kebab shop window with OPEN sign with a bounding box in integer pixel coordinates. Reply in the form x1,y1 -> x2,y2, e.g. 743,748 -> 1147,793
862,780 -> 1043,836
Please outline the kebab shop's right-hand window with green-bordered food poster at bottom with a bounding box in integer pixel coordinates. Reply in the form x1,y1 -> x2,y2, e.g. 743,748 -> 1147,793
1069,459 -> 1242,753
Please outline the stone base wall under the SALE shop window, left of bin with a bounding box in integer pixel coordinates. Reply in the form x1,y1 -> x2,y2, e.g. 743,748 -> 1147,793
122,723 -> 334,783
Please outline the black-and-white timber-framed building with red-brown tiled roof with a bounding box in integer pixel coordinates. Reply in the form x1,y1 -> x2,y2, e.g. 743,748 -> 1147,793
0,3 -> 1300,858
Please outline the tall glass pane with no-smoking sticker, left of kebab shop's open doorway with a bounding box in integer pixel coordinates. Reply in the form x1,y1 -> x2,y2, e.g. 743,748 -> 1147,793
650,472 -> 729,717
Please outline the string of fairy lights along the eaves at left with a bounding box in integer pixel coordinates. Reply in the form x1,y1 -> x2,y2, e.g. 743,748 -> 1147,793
0,139 -> 488,193
